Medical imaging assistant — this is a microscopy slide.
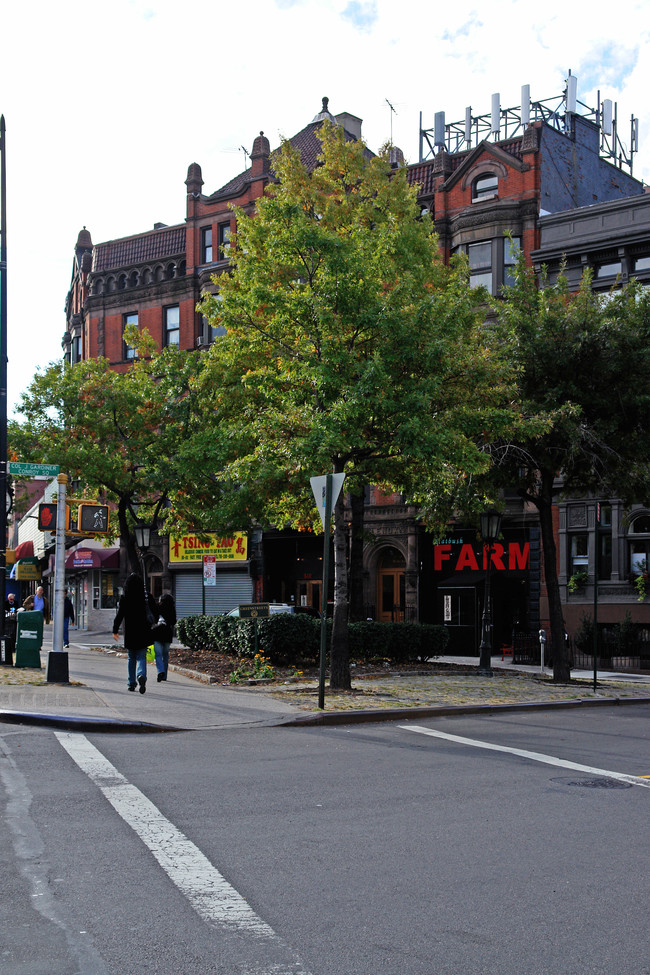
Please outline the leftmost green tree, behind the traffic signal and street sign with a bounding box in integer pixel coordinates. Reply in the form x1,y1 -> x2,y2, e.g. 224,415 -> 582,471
8,330 -> 202,570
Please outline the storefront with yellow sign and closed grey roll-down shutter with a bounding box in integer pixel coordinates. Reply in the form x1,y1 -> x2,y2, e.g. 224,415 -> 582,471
169,532 -> 253,619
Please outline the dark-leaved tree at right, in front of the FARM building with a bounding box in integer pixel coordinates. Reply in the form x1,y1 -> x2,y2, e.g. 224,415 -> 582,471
493,257 -> 650,681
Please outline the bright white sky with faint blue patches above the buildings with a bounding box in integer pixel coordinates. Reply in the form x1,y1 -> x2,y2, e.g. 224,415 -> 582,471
0,0 -> 650,415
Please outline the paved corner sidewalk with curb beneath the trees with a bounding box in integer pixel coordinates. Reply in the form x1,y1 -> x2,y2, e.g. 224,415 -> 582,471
0,628 -> 650,733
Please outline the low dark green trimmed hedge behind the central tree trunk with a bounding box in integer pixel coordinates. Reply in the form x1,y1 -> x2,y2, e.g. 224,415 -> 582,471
178,613 -> 449,666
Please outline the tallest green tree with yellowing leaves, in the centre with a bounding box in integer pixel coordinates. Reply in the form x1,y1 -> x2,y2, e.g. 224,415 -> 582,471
194,126 -> 513,688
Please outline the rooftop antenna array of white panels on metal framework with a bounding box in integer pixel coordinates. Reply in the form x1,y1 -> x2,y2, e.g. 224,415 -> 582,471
420,71 -> 639,175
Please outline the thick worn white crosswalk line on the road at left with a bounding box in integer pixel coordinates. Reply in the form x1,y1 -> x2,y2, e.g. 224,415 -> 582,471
55,731 -> 310,975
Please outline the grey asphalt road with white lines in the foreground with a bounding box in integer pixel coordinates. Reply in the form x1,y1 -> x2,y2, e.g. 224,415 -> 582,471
0,705 -> 650,975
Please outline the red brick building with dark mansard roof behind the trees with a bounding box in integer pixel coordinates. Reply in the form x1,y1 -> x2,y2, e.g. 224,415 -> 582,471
63,79 -> 642,652
